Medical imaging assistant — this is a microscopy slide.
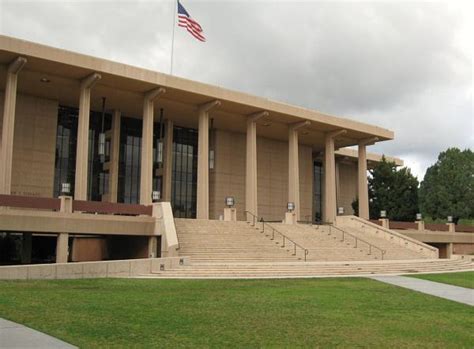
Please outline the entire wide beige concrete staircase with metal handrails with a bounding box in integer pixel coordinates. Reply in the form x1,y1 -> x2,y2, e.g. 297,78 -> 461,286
143,219 -> 473,278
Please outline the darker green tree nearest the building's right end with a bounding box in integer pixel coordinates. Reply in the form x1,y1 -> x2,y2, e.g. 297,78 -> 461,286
352,157 -> 418,221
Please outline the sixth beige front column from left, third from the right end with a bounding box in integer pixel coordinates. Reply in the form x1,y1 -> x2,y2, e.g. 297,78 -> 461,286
288,121 -> 311,221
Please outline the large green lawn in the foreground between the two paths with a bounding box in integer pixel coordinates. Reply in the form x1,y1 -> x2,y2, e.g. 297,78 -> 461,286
0,278 -> 474,348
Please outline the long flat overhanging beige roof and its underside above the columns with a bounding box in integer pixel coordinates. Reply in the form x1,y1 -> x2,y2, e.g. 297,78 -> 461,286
0,35 -> 394,150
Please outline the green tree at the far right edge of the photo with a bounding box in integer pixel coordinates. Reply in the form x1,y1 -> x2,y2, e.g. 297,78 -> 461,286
420,148 -> 474,223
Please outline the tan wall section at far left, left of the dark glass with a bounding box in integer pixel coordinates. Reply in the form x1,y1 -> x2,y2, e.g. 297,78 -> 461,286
0,92 -> 58,197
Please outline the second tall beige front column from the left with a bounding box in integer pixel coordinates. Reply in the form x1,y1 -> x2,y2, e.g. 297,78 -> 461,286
74,73 -> 101,200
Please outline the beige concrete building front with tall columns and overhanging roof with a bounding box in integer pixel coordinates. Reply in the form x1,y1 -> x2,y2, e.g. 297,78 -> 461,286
0,36 -> 401,262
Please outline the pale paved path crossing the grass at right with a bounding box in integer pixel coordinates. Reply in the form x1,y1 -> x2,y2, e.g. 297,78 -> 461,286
370,276 -> 474,306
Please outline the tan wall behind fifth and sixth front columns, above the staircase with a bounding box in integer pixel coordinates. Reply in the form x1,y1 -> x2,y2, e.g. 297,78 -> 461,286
209,130 -> 313,220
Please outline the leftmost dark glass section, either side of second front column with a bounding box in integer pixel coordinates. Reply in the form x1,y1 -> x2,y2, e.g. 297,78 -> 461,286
54,106 -> 112,201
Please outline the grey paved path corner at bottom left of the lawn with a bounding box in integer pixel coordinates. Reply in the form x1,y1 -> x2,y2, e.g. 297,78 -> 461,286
0,318 -> 77,349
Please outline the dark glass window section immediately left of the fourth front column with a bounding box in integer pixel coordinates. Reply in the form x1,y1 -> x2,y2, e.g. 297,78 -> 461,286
171,127 -> 198,218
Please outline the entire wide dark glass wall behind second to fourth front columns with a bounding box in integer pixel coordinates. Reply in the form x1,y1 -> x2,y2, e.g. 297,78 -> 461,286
54,106 -> 198,218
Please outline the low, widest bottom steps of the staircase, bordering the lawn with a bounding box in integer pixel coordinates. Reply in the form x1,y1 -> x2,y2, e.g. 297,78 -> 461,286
139,259 -> 474,279
